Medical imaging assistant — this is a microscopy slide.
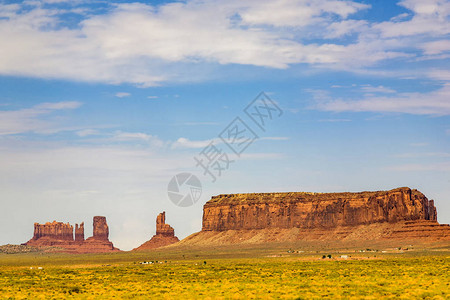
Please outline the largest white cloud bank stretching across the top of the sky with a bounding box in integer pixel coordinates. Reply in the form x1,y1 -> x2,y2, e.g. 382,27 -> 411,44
0,0 -> 428,87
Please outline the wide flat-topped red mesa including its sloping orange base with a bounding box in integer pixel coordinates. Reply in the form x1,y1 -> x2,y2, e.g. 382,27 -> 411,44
180,187 -> 450,245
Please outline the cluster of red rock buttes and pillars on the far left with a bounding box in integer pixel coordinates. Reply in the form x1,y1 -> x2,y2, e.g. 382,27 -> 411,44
24,217 -> 120,253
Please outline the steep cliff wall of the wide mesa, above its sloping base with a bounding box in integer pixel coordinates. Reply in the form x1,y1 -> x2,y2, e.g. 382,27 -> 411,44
202,187 -> 437,231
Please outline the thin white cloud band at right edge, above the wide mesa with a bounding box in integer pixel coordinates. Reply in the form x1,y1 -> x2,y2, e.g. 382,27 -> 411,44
315,84 -> 450,115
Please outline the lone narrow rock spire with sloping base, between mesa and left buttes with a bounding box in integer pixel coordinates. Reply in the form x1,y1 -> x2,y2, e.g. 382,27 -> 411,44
133,212 -> 179,251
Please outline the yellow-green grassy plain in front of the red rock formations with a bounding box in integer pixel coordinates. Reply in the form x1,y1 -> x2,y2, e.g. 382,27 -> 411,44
0,248 -> 450,299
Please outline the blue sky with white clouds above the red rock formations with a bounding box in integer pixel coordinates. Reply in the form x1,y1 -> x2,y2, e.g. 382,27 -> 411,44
0,0 -> 450,250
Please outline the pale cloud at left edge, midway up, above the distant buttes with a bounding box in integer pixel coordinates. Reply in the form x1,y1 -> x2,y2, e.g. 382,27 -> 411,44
0,101 -> 82,135
